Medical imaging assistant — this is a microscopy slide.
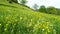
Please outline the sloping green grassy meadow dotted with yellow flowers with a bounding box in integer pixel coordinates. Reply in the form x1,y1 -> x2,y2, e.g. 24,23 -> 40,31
0,0 -> 60,34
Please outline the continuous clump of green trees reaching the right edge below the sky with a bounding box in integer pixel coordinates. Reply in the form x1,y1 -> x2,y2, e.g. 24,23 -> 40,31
39,5 -> 60,15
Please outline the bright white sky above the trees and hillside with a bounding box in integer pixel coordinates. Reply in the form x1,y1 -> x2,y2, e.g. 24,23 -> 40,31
26,0 -> 60,8
